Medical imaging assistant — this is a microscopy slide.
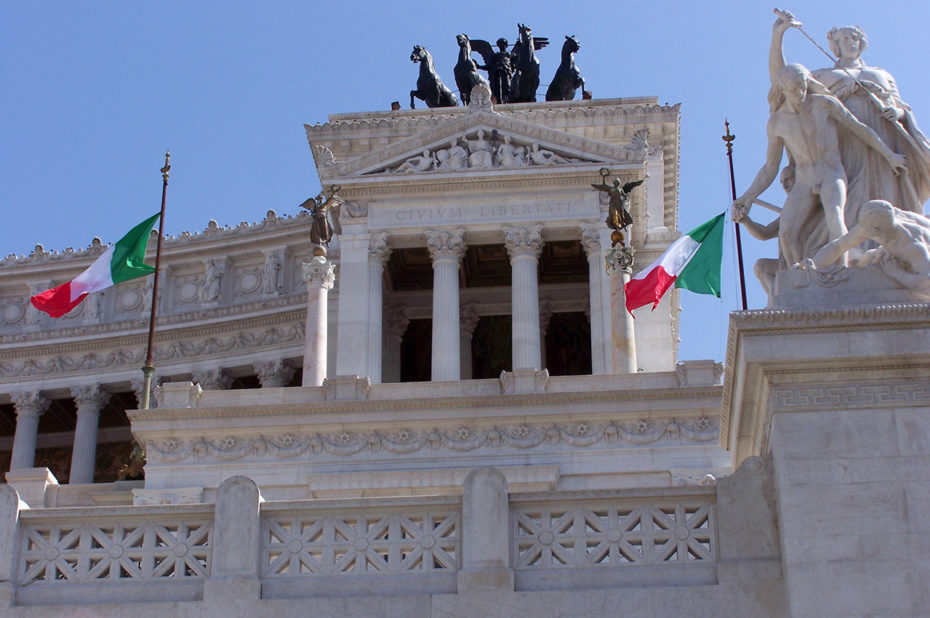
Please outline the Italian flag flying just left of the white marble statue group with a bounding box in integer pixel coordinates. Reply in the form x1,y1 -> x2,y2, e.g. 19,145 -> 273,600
624,213 -> 726,313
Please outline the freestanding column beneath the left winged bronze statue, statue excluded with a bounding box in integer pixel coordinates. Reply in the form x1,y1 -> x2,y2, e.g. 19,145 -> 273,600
301,255 -> 341,386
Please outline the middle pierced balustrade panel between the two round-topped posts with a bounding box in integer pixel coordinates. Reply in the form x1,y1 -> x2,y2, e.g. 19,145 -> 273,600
261,496 -> 462,596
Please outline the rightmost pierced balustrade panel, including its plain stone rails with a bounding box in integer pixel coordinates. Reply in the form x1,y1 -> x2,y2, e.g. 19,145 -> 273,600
510,488 -> 717,589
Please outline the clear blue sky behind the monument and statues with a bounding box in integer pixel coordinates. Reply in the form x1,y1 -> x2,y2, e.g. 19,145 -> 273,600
0,0 -> 930,360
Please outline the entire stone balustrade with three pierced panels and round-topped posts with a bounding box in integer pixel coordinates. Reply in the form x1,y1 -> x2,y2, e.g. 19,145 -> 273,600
0,468 -> 717,606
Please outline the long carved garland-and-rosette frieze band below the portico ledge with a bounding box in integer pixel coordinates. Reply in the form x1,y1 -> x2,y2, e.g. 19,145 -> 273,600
146,417 -> 719,463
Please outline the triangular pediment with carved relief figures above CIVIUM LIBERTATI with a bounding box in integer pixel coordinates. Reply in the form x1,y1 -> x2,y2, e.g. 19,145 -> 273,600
319,110 -> 648,180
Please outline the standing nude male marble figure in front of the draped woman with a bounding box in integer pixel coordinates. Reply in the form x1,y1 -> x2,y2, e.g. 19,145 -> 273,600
733,64 -> 907,265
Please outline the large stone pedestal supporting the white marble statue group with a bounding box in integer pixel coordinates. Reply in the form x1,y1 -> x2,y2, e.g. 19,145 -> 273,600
721,290 -> 930,616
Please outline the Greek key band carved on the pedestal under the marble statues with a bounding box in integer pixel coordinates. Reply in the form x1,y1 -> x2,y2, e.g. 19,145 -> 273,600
770,380 -> 930,410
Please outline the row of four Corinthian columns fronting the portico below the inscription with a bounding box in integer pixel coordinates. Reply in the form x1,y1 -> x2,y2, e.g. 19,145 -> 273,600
334,224 -> 626,384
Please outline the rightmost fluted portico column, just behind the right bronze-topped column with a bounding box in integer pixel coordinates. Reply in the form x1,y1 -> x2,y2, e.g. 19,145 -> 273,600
581,225 -> 613,375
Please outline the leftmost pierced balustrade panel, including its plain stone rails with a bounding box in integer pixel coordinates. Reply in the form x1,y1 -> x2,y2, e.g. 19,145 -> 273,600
14,504 -> 214,603
